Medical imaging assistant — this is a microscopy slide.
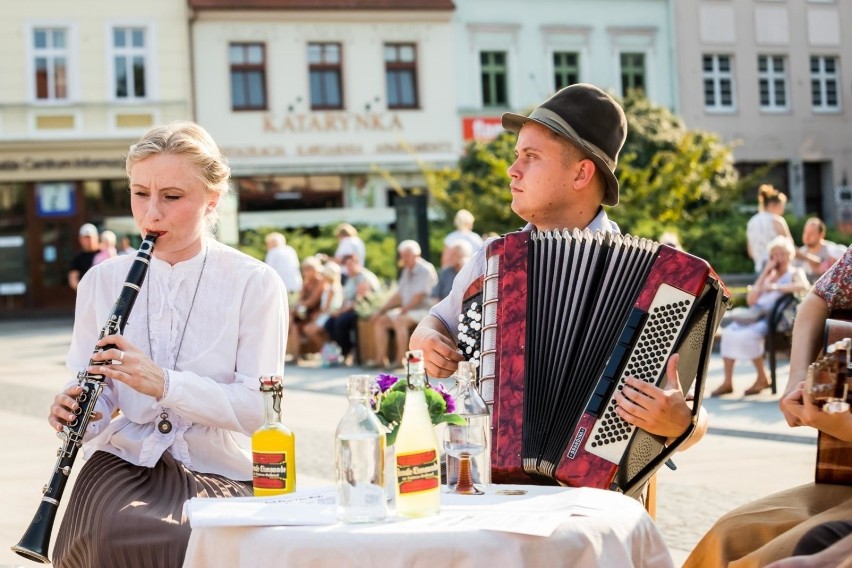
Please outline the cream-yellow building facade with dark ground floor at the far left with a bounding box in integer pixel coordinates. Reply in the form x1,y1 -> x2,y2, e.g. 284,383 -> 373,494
0,0 -> 192,315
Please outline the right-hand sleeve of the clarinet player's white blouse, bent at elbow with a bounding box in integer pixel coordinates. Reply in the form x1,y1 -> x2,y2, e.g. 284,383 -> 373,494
159,267 -> 288,435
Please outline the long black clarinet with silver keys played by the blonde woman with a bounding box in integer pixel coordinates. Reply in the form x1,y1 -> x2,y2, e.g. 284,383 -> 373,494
12,234 -> 158,564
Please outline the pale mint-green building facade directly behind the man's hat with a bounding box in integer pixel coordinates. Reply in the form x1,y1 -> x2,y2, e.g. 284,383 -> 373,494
454,0 -> 678,140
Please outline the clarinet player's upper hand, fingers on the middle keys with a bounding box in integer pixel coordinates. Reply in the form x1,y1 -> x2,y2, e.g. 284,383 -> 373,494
88,335 -> 166,400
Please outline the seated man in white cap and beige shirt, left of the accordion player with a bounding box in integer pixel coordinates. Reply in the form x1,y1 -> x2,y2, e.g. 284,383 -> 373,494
370,240 -> 438,368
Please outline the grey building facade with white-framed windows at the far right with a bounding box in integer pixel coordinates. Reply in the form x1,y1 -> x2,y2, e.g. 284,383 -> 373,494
674,0 -> 852,228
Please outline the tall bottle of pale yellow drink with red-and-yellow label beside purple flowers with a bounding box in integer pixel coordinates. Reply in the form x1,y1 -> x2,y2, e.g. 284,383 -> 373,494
394,350 -> 441,517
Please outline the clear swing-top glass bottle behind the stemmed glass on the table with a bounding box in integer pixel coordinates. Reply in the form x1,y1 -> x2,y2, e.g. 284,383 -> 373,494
445,361 -> 491,486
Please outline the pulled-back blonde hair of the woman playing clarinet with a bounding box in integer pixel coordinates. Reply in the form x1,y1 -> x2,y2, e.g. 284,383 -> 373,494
125,121 -> 231,227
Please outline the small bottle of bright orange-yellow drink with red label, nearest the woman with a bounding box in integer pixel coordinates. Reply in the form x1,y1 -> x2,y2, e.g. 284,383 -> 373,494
251,375 -> 296,497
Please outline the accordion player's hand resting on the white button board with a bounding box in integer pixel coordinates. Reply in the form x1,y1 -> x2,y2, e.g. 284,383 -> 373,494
615,354 -> 692,438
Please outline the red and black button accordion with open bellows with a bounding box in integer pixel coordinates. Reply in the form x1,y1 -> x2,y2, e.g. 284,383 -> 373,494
460,231 -> 728,494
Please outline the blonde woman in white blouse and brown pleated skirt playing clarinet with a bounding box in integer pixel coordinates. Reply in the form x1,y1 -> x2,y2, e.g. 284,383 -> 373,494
49,122 -> 288,568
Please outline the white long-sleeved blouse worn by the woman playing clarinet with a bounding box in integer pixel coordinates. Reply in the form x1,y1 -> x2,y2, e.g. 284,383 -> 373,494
66,239 -> 288,480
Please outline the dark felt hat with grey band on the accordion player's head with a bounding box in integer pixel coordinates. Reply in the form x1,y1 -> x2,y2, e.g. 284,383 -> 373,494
503,83 -> 627,205
